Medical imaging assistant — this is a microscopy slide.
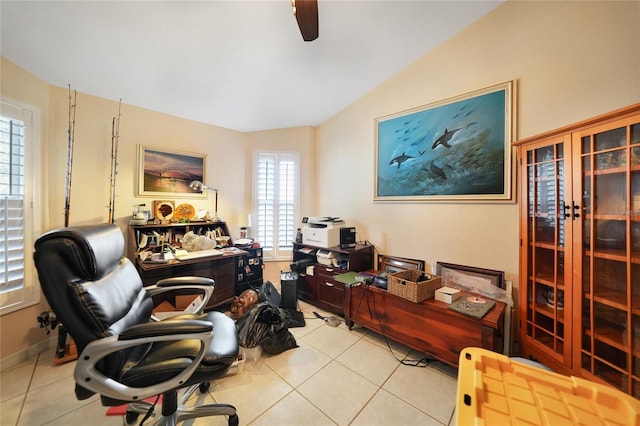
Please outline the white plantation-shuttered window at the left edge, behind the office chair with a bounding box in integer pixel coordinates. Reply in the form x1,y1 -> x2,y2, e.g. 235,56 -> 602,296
0,101 -> 40,313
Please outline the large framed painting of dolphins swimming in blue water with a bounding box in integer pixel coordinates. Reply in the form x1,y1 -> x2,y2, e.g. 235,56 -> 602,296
374,81 -> 516,202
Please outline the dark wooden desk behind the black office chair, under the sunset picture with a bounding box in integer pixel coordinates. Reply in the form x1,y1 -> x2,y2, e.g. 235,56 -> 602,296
135,250 -> 248,308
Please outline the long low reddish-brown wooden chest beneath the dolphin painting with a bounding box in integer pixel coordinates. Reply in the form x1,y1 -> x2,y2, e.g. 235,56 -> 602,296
344,285 -> 505,367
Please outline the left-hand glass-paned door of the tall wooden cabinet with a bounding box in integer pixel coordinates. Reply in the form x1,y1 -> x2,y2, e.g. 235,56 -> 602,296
524,138 -> 571,361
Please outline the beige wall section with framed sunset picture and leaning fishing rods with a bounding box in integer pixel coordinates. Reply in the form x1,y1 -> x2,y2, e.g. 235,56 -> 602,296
49,87 -> 246,229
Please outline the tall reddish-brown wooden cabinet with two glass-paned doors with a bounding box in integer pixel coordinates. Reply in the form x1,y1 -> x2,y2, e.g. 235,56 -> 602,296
517,104 -> 640,398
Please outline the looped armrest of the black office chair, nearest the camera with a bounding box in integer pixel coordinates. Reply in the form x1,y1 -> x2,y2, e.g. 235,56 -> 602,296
73,320 -> 213,401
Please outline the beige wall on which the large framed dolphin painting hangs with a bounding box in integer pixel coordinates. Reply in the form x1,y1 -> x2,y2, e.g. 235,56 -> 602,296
316,2 -> 640,281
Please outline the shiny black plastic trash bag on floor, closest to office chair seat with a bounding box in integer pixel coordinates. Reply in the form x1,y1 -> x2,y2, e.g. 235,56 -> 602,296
236,302 -> 298,354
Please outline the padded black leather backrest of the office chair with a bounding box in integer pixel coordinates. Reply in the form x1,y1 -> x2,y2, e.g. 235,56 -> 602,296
34,224 -> 153,375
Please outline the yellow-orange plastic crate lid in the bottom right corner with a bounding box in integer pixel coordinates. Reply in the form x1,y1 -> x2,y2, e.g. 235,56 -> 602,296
456,348 -> 640,426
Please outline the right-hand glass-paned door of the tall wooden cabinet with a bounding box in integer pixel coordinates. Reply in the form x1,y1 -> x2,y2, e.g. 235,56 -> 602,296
574,117 -> 640,397
